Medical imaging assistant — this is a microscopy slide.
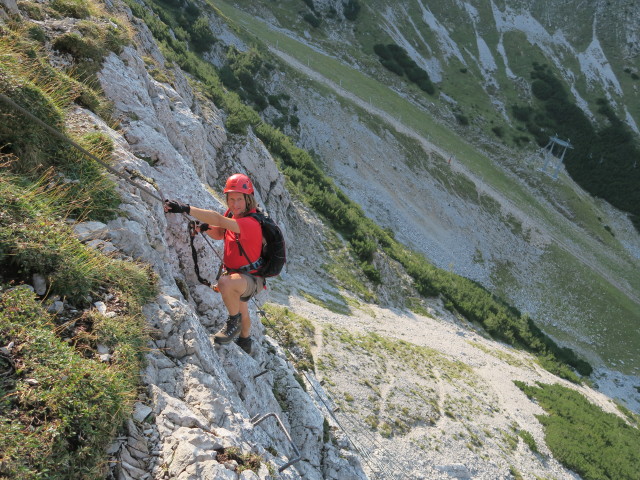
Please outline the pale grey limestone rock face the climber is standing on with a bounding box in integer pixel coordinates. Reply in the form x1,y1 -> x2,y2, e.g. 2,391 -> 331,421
68,5 -> 365,480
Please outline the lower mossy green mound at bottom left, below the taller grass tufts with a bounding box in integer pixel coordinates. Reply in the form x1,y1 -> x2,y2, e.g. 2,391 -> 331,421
0,173 -> 156,480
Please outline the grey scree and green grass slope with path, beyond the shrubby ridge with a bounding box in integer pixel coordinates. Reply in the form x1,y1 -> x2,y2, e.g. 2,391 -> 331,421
211,3 -> 640,372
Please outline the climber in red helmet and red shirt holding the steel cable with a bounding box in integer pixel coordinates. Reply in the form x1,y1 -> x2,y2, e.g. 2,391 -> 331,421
164,173 -> 265,354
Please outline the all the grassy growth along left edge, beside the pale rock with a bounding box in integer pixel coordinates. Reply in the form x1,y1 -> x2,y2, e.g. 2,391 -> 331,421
0,20 -> 157,480
